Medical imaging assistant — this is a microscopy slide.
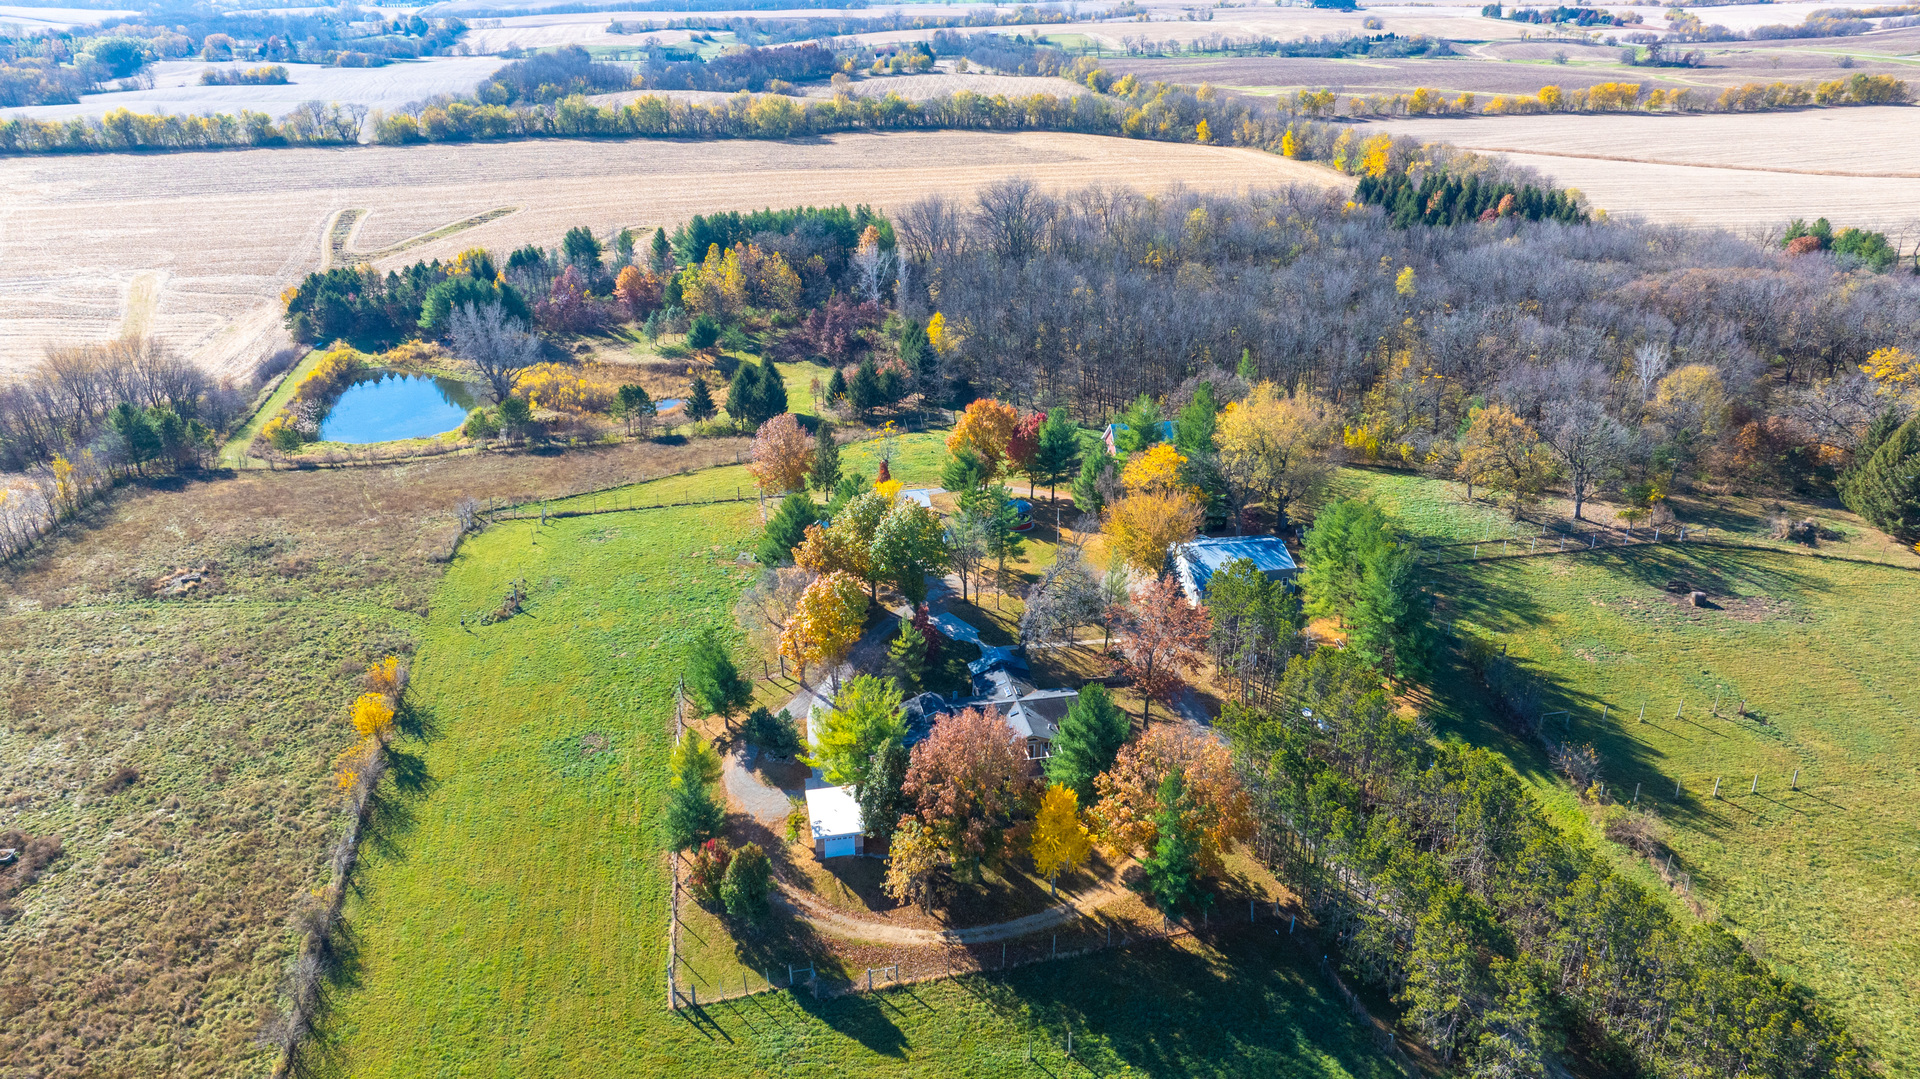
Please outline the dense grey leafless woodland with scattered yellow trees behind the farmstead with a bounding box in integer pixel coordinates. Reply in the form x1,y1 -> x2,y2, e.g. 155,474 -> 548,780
895,179 -> 1920,520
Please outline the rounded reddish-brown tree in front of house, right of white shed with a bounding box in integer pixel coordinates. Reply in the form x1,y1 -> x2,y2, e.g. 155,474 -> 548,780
900,708 -> 1033,881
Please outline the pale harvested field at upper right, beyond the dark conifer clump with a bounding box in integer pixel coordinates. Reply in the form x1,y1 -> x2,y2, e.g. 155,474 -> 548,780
1380,106 -> 1920,230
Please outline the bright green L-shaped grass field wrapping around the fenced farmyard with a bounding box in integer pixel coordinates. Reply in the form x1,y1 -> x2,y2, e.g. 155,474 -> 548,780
323,467 -> 1396,1079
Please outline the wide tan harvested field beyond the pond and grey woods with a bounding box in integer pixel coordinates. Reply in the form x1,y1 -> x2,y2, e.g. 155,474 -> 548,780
0,132 -> 1352,376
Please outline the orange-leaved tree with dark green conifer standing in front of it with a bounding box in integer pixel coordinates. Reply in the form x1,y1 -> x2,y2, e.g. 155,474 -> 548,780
1089,724 -> 1254,872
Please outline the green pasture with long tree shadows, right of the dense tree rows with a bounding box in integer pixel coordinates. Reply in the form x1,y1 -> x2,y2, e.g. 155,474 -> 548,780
1346,464 -> 1920,1075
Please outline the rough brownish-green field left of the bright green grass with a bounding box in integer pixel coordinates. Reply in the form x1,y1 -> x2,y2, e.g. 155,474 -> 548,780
0,440 -> 745,1079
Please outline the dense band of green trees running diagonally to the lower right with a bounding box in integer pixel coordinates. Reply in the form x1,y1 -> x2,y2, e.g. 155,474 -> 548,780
1221,649 -> 1872,1077
